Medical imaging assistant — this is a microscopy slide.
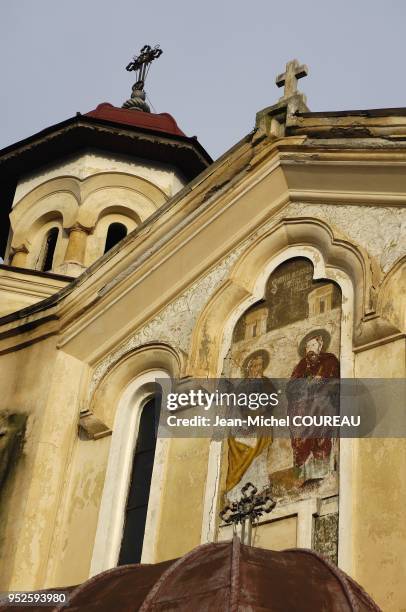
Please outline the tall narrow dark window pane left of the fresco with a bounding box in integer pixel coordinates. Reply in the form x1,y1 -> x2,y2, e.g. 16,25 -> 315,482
118,396 -> 160,565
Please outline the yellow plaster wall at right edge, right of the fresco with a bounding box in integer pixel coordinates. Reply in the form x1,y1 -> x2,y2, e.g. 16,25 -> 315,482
353,339 -> 406,612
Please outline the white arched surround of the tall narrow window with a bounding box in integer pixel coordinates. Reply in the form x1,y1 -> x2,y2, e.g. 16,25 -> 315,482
90,368 -> 170,576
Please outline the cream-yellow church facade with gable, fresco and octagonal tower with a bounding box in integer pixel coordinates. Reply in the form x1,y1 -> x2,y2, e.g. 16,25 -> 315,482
0,62 -> 406,611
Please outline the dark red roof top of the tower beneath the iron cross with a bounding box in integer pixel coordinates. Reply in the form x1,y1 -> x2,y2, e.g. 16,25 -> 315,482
85,102 -> 186,136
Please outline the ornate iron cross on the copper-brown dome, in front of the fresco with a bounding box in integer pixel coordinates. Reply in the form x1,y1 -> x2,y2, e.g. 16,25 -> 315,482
220,482 -> 276,546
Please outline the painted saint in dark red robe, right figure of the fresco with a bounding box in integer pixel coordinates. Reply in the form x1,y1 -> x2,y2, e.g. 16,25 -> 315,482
287,329 -> 340,482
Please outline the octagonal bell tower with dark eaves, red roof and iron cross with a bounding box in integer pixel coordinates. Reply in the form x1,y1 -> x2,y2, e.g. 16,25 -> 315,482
0,45 -> 212,314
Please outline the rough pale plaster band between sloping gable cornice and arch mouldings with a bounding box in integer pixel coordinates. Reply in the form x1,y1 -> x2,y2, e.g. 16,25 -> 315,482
90,203 -> 406,393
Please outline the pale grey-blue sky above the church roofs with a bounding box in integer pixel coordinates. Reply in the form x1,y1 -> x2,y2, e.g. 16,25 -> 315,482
0,0 -> 406,158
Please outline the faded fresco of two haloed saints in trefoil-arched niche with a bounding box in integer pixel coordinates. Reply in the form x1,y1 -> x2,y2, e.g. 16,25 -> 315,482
223,258 -> 341,501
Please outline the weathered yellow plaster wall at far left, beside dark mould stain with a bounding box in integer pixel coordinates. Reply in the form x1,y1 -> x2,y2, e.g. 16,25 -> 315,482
0,337 -> 82,590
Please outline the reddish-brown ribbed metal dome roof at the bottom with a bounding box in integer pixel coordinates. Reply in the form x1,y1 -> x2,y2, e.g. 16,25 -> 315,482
0,538 -> 380,612
